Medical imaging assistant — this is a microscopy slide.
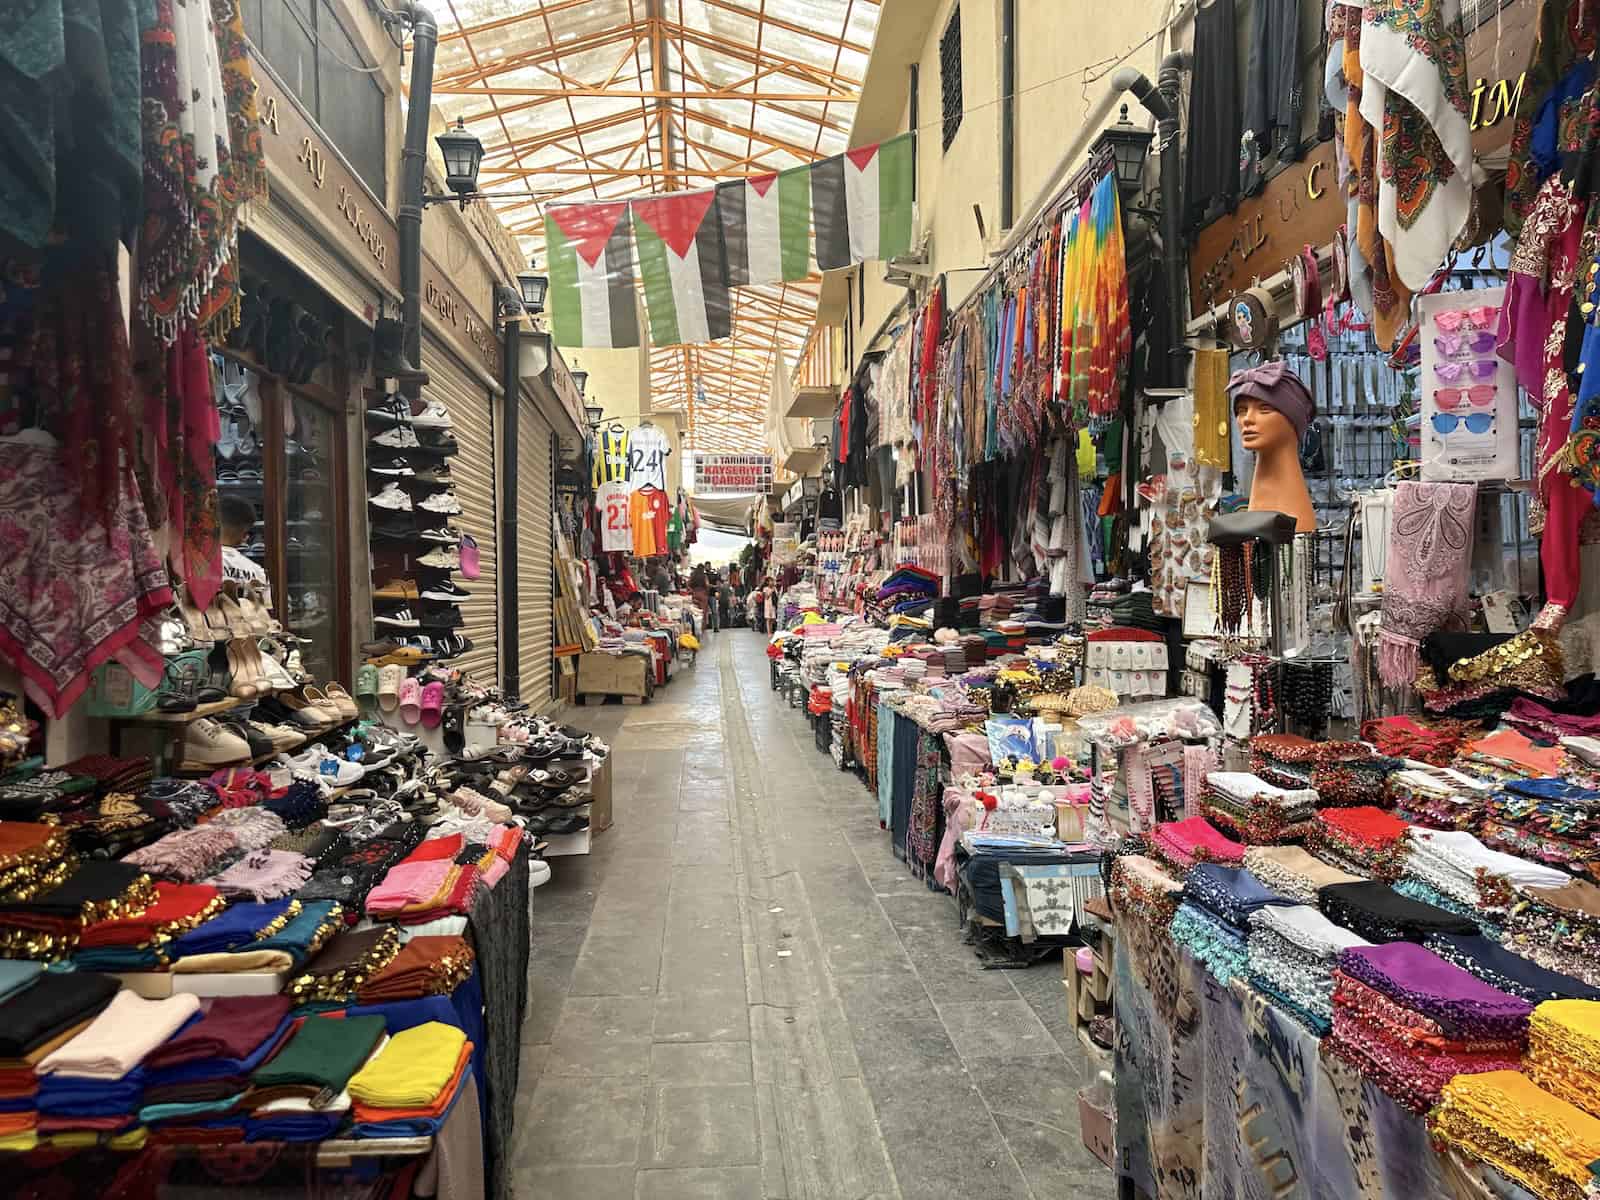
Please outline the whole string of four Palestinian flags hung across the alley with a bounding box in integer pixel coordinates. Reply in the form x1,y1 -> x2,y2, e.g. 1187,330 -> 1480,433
544,133 -> 914,347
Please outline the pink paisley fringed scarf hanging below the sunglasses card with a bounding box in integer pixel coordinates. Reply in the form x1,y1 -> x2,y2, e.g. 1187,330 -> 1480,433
1378,482 -> 1478,688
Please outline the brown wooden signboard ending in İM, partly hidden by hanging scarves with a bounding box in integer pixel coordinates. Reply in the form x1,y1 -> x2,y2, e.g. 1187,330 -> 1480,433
1189,0 -> 1539,317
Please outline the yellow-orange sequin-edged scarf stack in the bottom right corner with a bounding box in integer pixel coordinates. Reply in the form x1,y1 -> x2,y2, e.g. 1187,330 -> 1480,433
1427,1070 -> 1600,1200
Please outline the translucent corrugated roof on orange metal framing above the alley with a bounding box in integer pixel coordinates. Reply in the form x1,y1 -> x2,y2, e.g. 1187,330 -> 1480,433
434,0 -> 878,450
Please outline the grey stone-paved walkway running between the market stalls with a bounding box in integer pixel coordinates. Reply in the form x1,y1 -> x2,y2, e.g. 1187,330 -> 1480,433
514,629 -> 1115,1200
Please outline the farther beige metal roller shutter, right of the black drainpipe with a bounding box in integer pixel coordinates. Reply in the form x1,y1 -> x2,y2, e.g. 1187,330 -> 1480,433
517,397 -> 554,709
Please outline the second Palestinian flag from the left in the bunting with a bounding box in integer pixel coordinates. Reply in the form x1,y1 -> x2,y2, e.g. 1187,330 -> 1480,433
629,190 -> 733,346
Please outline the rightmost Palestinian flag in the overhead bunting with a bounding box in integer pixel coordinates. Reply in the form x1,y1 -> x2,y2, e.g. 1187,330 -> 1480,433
811,133 -> 914,270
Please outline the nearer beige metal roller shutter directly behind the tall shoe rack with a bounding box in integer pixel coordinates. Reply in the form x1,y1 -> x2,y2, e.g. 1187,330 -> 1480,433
422,336 -> 499,686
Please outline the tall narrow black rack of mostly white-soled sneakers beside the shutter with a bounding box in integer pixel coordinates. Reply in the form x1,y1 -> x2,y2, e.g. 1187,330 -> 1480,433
366,394 -> 472,661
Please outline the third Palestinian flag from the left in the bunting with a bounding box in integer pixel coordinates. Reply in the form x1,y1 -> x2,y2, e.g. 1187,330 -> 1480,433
717,166 -> 811,288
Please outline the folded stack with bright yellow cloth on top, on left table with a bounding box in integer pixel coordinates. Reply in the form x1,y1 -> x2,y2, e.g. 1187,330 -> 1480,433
350,1021 -> 472,1138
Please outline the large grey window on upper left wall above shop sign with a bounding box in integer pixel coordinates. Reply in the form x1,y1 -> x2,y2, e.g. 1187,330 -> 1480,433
243,0 -> 386,198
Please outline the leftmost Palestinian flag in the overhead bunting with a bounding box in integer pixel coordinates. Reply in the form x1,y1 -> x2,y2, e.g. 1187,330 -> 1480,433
544,200 -> 638,347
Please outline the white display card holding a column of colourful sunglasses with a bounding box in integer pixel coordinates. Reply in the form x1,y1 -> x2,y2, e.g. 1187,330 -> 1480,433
1418,288 -> 1517,483
